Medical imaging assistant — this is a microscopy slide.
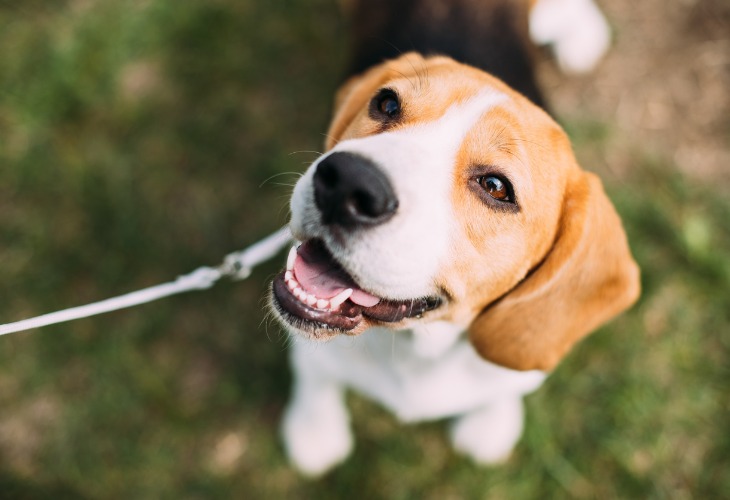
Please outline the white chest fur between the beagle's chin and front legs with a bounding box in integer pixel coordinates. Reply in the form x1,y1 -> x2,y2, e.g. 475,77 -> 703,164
292,322 -> 545,422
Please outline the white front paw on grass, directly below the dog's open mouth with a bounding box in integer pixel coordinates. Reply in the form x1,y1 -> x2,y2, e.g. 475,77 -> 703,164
282,388 -> 353,477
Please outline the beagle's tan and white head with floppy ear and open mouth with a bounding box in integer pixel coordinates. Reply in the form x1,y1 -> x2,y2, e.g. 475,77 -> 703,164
272,54 -> 639,370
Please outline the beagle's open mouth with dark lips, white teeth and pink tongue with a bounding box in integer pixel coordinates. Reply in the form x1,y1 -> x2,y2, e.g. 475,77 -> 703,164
272,240 -> 442,332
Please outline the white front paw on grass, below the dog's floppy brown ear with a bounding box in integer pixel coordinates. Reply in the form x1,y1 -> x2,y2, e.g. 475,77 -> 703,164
451,398 -> 524,465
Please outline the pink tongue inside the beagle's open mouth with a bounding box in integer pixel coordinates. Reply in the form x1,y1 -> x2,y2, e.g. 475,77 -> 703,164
294,243 -> 380,307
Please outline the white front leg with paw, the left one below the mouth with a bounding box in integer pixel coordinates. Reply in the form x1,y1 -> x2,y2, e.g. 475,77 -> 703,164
282,344 -> 353,477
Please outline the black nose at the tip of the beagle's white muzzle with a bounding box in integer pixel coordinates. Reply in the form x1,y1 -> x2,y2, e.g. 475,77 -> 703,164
314,153 -> 398,228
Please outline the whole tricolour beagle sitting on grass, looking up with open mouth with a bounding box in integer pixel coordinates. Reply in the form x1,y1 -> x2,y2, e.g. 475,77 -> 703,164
271,0 -> 639,476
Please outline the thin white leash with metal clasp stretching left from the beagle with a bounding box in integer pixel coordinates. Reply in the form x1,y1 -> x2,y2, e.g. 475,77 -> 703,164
0,227 -> 292,336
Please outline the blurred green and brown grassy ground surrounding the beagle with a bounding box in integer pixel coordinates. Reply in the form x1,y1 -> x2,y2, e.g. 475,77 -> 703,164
0,0 -> 730,499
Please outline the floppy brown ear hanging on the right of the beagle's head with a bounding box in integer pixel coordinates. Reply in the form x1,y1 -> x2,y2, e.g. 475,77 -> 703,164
469,171 -> 640,370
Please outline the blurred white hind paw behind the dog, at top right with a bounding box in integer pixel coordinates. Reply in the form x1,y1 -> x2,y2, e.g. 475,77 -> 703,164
530,0 -> 611,73
